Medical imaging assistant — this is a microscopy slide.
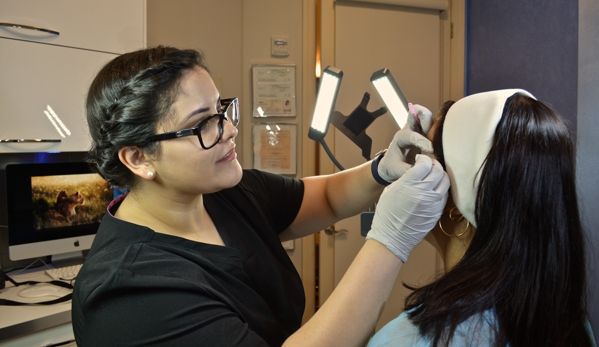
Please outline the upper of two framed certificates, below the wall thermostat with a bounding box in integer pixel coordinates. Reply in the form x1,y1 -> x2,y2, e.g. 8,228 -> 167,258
252,64 -> 297,118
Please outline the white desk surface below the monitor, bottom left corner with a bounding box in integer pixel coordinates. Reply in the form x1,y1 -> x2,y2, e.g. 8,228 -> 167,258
0,270 -> 71,341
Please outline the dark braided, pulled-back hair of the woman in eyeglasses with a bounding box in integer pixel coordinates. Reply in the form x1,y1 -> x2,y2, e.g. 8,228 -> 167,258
86,46 -> 208,188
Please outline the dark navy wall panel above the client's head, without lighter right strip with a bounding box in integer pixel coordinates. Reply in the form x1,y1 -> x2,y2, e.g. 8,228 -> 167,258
466,0 -> 578,133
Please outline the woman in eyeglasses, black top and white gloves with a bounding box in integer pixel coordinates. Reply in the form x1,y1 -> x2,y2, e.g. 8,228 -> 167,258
72,47 -> 449,347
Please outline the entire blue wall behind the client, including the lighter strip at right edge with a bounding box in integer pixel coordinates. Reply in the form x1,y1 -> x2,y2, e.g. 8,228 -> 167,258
465,0 -> 599,341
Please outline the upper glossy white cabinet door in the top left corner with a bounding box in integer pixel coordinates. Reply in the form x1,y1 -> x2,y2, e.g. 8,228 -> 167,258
0,0 -> 146,53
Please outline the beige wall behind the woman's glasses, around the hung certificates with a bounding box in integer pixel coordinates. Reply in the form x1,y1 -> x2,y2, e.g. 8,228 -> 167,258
147,0 -> 303,273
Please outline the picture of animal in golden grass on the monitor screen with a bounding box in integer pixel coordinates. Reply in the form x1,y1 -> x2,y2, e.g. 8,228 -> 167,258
31,173 -> 113,230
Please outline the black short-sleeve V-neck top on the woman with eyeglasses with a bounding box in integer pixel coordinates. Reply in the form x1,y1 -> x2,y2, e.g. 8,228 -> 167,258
72,170 -> 305,347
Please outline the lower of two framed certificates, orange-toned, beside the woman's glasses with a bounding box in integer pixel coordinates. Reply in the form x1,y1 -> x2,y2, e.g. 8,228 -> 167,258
252,123 -> 297,175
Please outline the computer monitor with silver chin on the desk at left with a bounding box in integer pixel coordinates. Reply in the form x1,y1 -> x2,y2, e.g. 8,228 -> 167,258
0,152 -> 116,266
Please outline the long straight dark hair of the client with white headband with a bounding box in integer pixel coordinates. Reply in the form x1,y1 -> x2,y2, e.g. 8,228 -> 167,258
406,95 -> 591,347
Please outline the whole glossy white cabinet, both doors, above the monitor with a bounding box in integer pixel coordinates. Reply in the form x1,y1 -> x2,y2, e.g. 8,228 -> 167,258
0,0 -> 145,152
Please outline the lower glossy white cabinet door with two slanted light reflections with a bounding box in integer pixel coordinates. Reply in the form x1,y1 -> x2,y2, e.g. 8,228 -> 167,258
0,38 -> 116,152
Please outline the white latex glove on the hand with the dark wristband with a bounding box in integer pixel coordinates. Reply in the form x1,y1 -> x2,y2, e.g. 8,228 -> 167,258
373,104 -> 433,184
